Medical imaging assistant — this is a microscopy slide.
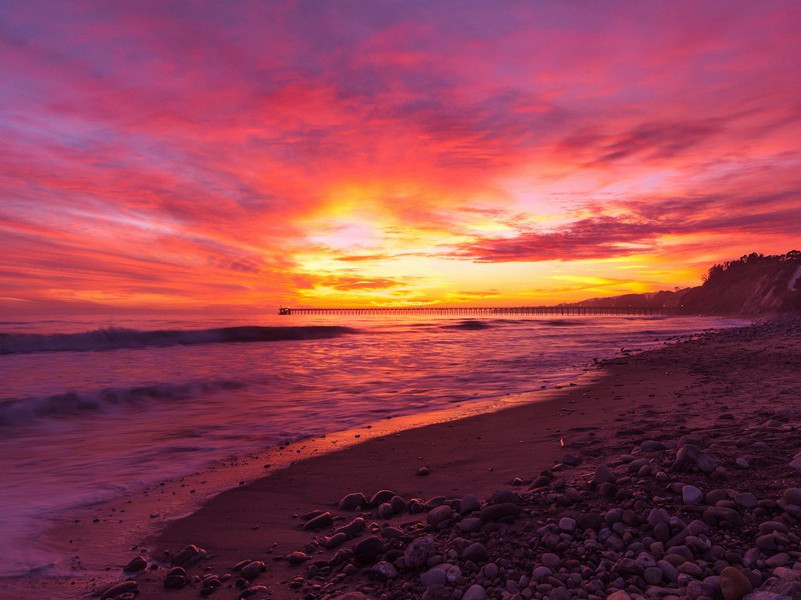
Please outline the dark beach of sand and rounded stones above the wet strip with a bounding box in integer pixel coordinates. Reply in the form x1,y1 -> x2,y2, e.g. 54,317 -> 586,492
99,318 -> 801,600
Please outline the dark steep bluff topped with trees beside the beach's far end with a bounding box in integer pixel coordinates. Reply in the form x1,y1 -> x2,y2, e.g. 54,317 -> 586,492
680,250 -> 801,315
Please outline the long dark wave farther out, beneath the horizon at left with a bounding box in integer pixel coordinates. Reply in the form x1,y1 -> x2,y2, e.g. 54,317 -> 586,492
0,325 -> 358,354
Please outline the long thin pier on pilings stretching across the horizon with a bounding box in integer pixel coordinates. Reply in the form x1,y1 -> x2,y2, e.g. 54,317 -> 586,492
278,306 -> 678,316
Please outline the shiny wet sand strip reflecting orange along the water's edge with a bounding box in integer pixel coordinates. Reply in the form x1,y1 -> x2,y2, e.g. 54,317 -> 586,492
0,358 -> 612,600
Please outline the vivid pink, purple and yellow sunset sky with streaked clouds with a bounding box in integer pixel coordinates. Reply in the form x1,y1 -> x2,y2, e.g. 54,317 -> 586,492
0,0 -> 801,314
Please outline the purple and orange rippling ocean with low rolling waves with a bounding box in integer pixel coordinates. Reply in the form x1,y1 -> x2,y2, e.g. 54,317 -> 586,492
0,315 -> 744,576
